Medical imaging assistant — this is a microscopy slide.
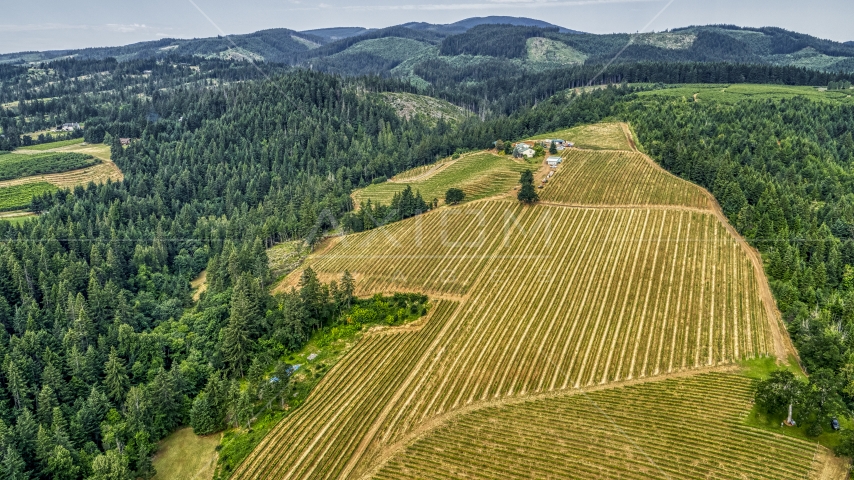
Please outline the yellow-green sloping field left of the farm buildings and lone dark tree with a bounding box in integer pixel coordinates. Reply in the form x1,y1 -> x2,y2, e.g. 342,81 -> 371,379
353,152 -> 529,205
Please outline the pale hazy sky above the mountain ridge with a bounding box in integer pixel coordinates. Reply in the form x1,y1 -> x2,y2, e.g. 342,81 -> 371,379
0,0 -> 854,53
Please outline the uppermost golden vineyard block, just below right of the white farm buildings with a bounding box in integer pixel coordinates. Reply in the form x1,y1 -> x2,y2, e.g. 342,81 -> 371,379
540,150 -> 709,208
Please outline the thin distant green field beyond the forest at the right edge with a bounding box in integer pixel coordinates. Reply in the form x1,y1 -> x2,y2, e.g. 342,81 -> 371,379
638,84 -> 854,104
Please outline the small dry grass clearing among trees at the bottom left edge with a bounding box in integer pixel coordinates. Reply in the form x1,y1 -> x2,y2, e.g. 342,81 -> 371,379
153,427 -> 222,480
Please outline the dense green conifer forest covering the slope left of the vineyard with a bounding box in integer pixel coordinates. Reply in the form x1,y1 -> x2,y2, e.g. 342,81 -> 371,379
0,71 -> 458,478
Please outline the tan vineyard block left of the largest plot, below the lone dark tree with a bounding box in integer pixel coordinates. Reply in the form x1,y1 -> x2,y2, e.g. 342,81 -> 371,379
313,202 -> 532,294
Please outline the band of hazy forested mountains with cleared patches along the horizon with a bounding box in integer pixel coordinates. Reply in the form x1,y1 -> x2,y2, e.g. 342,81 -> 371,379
0,16 -> 854,77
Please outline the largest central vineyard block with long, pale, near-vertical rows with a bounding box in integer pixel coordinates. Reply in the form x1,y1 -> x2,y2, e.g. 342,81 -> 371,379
368,207 -> 772,452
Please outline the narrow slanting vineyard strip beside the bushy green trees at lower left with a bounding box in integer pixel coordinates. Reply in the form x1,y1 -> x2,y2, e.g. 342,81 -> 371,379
234,301 -> 458,478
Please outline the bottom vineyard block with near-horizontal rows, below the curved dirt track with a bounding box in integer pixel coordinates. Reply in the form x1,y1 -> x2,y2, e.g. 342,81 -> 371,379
375,373 -> 820,480
